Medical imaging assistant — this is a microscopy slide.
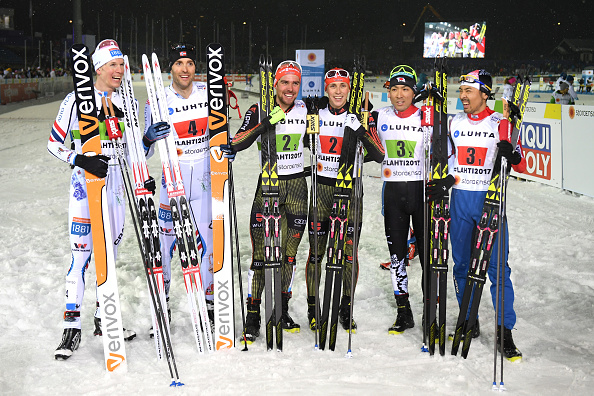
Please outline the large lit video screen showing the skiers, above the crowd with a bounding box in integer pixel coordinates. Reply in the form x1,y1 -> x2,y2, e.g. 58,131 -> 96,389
423,22 -> 487,58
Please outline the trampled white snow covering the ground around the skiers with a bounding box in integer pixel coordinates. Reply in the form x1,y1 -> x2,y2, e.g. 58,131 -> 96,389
0,83 -> 594,395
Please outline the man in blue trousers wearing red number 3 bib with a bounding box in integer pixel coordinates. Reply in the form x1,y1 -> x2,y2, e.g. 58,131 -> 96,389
427,69 -> 526,360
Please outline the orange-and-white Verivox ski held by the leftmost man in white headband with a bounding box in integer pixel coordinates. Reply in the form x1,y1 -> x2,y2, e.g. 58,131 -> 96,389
70,44 -> 128,373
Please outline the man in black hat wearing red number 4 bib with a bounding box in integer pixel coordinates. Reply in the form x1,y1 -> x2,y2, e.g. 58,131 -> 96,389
143,43 -> 214,337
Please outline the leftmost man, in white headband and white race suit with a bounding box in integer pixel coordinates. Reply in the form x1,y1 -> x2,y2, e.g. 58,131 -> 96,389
47,39 -> 139,360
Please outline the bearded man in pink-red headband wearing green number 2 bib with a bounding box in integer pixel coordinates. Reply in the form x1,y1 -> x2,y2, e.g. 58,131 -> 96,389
221,60 -> 307,343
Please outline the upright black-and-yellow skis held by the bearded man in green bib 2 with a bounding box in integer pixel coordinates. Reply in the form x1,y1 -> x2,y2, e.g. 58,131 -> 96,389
260,55 -> 283,351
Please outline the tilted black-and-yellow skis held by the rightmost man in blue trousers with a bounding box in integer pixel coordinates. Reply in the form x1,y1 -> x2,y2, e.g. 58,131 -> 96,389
452,78 -> 530,359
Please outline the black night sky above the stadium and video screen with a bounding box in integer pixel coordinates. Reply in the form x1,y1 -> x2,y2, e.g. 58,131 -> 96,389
0,0 -> 594,65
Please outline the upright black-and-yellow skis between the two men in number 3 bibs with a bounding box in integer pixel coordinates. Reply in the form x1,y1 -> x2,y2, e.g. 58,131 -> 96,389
425,58 -> 450,356
